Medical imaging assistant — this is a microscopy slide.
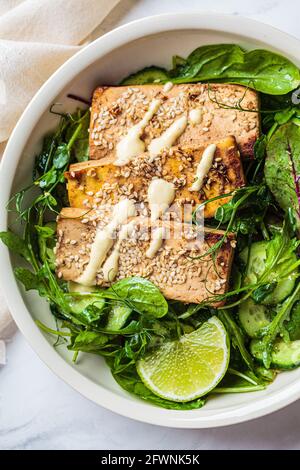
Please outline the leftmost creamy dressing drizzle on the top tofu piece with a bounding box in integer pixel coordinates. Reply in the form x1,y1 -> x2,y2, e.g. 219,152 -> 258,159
114,99 -> 161,166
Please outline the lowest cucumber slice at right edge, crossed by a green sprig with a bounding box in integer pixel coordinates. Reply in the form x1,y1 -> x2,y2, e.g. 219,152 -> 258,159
250,339 -> 300,369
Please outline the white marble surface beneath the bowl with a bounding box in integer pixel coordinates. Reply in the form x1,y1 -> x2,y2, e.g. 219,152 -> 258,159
0,0 -> 300,449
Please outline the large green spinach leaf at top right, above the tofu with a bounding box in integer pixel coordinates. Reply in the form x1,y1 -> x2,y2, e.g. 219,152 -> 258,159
170,44 -> 300,95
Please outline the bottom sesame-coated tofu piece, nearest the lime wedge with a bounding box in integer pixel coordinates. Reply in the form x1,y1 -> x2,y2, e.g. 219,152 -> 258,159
56,208 -> 234,306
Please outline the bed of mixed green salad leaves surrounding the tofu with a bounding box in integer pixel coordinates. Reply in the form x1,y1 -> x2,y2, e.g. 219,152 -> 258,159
4,39 -> 300,410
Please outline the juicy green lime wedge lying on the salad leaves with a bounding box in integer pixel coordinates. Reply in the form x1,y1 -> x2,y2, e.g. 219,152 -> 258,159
137,317 -> 230,402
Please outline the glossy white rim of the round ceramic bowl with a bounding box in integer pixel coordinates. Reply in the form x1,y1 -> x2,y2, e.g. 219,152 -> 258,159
0,11 -> 300,428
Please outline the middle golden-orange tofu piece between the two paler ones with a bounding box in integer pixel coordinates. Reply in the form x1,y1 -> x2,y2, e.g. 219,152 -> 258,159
66,136 -> 245,218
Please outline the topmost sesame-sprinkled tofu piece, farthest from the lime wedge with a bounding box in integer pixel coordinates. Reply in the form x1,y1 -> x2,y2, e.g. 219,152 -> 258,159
90,83 -> 260,160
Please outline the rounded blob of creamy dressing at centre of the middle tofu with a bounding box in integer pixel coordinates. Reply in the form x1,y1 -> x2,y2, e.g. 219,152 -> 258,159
148,178 -> 175,222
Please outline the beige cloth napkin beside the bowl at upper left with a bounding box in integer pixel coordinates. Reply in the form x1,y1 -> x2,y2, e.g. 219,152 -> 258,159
0,0 -> 120,365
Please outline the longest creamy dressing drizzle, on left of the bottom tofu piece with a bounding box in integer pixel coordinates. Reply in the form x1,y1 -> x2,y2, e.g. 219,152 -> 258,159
76,199 -> 136,286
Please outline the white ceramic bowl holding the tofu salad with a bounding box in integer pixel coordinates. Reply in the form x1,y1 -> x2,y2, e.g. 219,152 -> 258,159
0,13 -> 300,428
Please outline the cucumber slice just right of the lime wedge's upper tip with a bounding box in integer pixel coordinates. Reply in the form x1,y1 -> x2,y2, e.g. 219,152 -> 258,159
238,299 -> 271,338
